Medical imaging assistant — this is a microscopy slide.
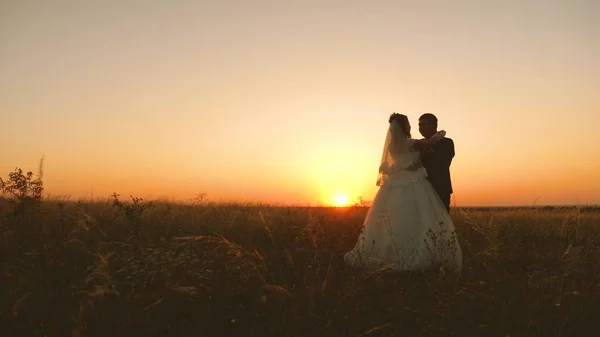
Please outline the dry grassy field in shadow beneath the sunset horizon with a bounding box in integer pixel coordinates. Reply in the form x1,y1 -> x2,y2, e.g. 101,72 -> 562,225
0,194 -> 600,337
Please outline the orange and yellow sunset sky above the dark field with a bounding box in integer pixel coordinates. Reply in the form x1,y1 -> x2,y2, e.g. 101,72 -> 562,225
0,0 -> 600,206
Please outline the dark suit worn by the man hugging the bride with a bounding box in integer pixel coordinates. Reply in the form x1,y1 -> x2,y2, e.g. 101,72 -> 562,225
420,138 -> 454,212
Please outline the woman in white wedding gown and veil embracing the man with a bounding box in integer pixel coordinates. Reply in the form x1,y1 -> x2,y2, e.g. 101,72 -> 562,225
344,113 -> 462,271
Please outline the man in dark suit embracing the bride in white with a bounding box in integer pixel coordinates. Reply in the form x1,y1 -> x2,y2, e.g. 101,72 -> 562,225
419,113 -> 454,213
